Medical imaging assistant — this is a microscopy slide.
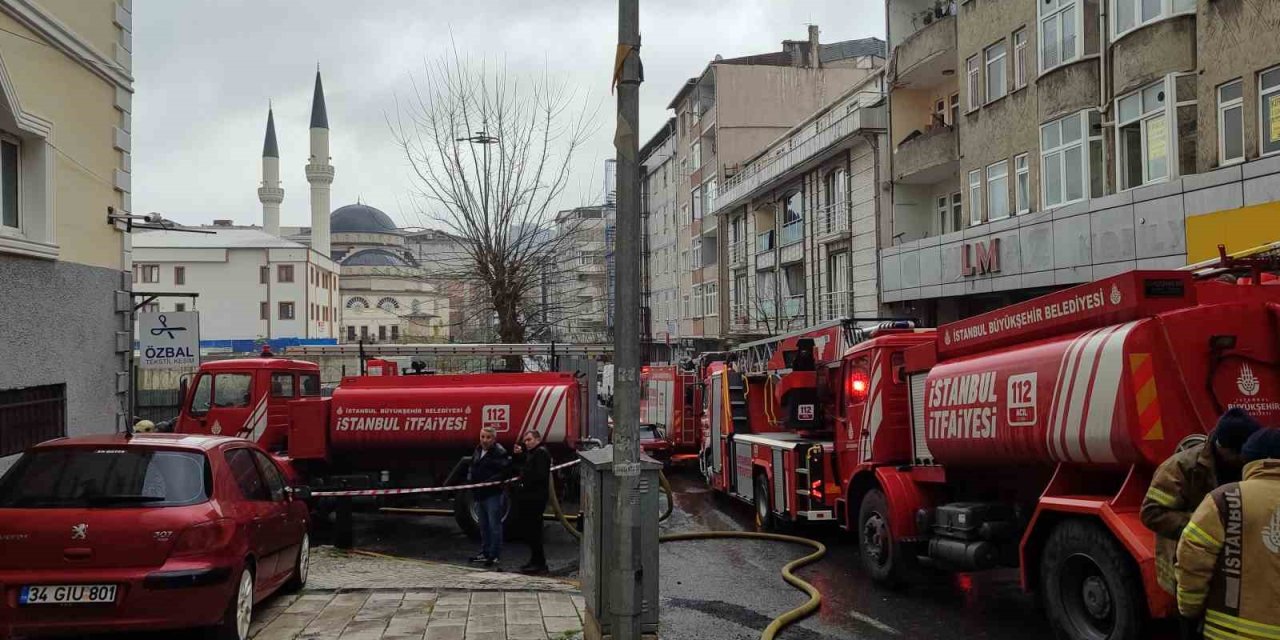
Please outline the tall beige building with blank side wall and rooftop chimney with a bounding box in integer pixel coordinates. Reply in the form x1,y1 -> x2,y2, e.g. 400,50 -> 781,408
641,26 -> 884,351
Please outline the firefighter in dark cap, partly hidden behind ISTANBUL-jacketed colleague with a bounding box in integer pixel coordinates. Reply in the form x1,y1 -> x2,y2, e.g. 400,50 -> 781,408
1142,407 -> 1261,595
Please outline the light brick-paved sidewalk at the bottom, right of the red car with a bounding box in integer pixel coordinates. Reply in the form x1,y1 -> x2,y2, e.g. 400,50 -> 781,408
250,590 -> 582,640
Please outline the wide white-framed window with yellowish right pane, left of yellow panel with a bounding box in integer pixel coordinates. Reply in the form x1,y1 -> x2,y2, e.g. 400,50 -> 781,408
1116,81 -> 1170,189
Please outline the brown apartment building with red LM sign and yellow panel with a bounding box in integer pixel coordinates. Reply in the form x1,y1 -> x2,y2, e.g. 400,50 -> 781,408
881,0 -> 1280,323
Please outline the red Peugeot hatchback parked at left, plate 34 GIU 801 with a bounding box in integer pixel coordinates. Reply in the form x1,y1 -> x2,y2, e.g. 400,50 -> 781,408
0,434 -> 310,640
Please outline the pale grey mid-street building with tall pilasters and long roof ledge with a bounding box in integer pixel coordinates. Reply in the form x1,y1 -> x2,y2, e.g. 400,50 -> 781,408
712,72 -> 887,340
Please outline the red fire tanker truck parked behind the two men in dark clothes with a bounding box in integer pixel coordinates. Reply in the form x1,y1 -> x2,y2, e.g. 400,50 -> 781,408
174,344 -> 612,535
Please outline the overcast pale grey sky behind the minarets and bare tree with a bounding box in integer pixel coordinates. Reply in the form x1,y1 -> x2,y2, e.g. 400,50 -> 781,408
132,0 -> 884,225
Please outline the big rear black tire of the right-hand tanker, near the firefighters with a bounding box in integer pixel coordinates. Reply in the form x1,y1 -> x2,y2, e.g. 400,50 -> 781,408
1039,520 -> 1146,640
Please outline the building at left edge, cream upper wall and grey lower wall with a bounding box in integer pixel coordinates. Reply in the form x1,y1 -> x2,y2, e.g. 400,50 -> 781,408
0,0 -> 133,471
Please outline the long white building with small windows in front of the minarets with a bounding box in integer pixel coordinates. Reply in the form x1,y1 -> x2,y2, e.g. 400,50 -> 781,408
133,226 -> 342,348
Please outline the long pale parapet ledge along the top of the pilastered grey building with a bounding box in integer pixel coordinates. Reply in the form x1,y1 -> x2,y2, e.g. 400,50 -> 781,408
710,91 -> 887,212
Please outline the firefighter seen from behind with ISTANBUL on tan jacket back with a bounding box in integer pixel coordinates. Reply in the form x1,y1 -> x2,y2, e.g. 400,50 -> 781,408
1178,429 -> 1280,640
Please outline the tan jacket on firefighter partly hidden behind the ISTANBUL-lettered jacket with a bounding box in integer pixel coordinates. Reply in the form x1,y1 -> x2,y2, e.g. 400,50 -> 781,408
1142,443 -> 1217,594
